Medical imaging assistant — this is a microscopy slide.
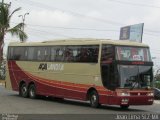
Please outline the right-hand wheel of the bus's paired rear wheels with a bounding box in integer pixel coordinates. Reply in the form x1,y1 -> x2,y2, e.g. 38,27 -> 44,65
28,84 -> 37,99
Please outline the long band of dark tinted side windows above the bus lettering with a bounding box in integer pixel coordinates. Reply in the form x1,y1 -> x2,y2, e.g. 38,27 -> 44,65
8,45 -> 99,63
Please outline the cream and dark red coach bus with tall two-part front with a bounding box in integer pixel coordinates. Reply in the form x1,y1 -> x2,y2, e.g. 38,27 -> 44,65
6,39 -> 154,108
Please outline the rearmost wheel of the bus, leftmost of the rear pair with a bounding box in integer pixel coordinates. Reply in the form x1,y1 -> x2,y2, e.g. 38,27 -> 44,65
19,83 -> 28,98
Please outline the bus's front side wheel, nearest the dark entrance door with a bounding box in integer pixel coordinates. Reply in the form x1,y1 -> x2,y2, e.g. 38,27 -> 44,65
89,90 -> 100,108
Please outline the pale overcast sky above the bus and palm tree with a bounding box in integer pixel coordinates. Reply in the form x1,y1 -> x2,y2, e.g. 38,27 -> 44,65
4,0 -> 160,71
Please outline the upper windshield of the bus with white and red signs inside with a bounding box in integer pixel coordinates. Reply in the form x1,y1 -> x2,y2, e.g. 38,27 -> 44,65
116,46 -> 151,62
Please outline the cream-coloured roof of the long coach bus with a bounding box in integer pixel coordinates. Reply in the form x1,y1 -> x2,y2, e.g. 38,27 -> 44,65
9,38 -> 148,47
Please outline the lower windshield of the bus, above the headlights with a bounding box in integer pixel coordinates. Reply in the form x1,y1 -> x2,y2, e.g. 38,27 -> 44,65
118,65 -> 153,89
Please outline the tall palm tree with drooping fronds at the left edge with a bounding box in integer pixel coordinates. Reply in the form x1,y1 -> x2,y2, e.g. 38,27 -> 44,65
0,1 -> 27,64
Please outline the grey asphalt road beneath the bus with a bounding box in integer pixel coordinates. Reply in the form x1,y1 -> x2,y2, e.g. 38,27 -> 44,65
0,85 -> 160,120
